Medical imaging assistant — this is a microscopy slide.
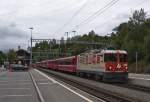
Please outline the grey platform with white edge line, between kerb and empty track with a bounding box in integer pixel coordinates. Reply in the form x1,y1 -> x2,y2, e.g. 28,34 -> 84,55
31,69 -> 104,102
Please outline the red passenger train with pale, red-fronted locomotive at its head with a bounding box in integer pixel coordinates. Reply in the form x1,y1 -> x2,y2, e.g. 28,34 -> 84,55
35,49 -> 128,82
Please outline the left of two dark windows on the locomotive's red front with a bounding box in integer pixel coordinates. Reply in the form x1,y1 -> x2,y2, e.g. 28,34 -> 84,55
104,53 -> 117,62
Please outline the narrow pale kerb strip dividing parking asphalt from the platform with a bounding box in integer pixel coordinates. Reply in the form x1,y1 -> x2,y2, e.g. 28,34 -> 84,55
28,71 -> 45,102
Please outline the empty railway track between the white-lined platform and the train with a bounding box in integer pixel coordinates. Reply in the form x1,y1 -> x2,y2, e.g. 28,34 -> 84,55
39,69 -> 137,102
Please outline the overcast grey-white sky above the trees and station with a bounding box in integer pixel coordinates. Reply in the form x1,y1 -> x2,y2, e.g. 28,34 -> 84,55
0,0 -> 150,50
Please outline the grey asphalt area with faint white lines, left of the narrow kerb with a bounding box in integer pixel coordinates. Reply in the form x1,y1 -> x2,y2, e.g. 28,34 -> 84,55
0,71 -> 39,102
